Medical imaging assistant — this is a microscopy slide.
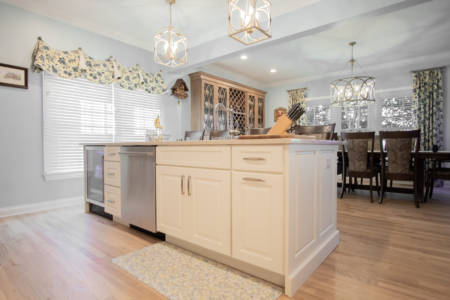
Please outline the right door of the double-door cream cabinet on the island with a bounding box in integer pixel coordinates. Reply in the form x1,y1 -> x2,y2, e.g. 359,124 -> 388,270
187,169 -> 231,255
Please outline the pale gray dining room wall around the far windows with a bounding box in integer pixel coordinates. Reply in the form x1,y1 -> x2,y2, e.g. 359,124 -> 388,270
266,61 -> 450,150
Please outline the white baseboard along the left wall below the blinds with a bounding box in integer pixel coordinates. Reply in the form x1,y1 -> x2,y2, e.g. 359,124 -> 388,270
0,197 -> 83,218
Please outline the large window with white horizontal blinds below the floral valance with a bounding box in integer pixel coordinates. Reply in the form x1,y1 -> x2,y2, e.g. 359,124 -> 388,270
43,73 -> 161,178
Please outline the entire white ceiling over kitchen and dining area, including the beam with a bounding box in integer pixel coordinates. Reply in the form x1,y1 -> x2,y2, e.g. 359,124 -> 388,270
0,0 -> 450,86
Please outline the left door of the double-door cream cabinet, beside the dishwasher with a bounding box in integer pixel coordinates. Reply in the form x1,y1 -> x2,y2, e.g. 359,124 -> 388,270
156,166 -> 188,238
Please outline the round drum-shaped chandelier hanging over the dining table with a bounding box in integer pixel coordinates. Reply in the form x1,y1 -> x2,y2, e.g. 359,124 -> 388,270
330,42 -> 375,107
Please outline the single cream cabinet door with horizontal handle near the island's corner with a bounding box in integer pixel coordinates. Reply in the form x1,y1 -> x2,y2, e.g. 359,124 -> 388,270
232,172 -> 284,274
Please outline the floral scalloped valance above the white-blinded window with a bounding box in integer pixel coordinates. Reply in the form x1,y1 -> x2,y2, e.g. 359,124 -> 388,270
31,38 -> 166,94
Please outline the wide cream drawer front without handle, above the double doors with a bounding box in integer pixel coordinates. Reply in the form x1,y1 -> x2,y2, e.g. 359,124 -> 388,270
156,146 -> 231,169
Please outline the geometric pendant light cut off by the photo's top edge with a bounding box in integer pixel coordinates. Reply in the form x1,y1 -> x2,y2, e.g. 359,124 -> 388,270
228,0 -> 272,45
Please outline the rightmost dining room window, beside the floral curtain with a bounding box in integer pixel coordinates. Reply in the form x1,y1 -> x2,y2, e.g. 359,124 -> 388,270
381,97 -> 417,129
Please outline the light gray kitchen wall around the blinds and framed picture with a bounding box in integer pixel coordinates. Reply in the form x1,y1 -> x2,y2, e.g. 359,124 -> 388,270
0,4 -> 190,207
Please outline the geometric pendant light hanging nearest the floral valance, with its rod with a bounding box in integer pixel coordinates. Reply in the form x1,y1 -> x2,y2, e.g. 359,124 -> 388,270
154,0 -> 188,68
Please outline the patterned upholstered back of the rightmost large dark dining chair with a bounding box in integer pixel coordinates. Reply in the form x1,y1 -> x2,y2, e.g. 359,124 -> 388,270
380,130 -> 420,175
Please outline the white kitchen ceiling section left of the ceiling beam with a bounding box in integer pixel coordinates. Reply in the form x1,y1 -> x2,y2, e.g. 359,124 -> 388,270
0,0 -> 319,51
